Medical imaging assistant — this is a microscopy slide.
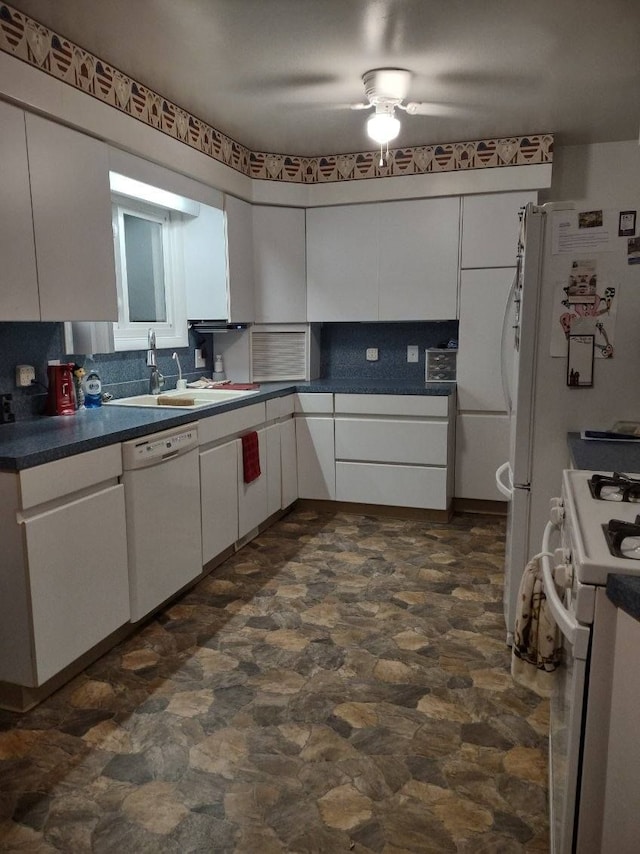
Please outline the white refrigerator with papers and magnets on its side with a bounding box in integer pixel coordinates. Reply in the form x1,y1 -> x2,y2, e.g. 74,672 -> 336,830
496,203 -> 640,643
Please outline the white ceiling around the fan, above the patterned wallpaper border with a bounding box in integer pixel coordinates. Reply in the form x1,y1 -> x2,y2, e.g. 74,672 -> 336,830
11,0 -> 640,156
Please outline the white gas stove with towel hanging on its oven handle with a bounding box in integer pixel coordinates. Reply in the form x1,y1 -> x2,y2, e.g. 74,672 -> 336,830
542,471 -> 640,854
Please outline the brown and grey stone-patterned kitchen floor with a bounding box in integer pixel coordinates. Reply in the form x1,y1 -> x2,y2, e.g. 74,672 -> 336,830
0,509 -> 548,854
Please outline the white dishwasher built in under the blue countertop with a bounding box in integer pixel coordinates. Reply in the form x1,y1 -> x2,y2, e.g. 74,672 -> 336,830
122,424 -> 202,622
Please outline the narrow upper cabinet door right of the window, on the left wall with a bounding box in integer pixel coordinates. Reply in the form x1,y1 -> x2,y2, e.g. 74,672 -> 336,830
224,196 -> 255,323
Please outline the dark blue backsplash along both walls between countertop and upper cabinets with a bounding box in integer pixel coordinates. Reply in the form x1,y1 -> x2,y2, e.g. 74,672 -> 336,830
0,320 -> 458,420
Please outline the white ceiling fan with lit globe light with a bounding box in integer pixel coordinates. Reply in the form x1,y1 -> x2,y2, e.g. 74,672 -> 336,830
351,68 -> 447,153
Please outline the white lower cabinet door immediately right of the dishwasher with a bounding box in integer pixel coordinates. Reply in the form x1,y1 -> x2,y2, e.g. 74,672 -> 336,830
200,441 -> 238,565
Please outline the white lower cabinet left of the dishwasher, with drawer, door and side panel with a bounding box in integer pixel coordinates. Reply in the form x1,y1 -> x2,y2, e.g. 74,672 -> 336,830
0,444 -> 129,688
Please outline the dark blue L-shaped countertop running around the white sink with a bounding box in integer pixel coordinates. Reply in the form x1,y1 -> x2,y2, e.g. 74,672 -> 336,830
0,380 -> 456,471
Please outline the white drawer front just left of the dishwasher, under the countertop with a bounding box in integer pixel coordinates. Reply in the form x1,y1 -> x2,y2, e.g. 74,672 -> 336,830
20,442 -> 122,510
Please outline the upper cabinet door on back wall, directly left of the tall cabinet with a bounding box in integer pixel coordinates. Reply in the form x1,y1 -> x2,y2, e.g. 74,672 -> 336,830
377,197 -> 460,320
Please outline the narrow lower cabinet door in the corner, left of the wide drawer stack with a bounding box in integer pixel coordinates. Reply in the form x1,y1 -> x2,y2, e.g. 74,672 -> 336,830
296,415 -> 336,501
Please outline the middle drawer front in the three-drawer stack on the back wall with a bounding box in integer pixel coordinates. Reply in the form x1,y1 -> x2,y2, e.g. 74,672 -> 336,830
335,417 -> 448,466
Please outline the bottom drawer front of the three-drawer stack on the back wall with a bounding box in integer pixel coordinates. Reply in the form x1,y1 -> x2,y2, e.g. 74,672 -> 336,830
336,462 -> 447,510
